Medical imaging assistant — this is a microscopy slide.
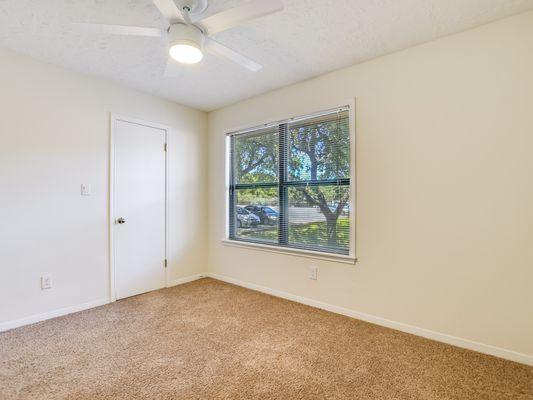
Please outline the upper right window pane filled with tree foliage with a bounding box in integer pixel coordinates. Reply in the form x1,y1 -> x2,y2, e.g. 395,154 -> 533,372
288,111 -> 350,181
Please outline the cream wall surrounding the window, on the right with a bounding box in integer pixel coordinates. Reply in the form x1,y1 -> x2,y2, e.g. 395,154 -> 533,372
208,13 -> 533,362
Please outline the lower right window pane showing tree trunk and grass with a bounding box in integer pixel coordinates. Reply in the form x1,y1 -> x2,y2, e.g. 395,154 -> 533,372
288,185 -> 350,253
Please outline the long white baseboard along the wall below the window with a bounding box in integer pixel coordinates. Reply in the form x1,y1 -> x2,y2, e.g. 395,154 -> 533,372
205,272 -> 533,365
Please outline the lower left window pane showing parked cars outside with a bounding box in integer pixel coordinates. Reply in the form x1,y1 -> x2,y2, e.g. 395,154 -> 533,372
235,188 -> 279,243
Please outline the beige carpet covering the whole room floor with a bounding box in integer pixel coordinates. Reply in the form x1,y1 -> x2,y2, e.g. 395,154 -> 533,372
0,279 -> 533,400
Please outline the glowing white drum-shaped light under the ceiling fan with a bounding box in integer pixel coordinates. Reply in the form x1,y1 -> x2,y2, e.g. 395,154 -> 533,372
168,24 -> 204,64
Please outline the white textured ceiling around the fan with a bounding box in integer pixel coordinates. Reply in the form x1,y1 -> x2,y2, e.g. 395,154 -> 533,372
0,0 -> 533,110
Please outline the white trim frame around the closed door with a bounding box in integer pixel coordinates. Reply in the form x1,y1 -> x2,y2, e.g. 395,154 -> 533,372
108,113 -> 170,302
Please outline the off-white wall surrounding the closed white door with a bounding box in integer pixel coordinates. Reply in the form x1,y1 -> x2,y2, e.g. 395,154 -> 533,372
0,50 -> 207,327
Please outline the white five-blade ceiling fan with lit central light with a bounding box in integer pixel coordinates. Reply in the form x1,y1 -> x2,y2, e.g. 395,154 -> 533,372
76,0 -> 283,76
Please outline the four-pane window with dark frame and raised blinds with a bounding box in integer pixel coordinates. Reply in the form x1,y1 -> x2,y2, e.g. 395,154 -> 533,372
229,107 -> 351,254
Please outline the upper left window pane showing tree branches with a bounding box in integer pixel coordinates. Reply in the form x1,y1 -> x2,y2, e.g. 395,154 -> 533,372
233,129 -> 279,183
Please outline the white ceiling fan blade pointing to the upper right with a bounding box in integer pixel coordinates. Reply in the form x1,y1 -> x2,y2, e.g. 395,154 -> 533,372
198,0 -> 283,35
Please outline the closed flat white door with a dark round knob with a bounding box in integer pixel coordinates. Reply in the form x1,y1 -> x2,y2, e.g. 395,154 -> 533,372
113,119 -> 166,299
